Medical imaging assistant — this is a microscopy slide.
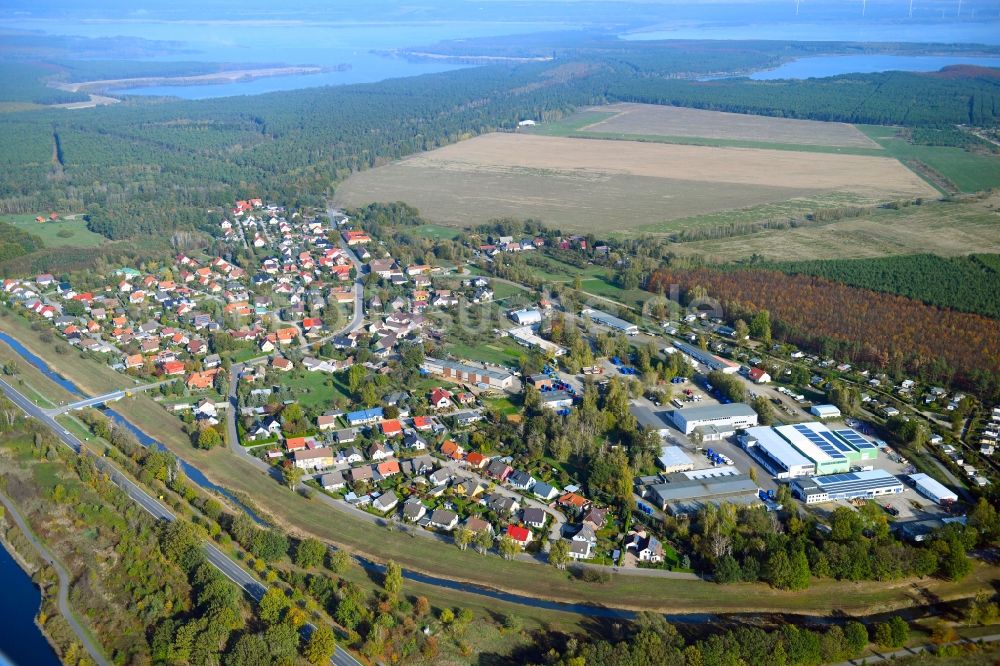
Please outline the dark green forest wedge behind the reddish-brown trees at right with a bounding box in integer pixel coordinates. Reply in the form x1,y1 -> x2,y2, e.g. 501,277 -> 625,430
753,254 -> 1000,318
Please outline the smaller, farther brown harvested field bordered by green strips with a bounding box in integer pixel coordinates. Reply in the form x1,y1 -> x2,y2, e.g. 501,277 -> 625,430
578,104 -> 880,149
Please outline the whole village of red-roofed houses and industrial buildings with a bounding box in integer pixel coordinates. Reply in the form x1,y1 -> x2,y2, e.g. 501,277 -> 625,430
2,199 -> 1000,570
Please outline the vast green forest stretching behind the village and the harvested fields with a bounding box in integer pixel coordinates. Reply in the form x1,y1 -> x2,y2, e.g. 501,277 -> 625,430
0,43 -> 1000,244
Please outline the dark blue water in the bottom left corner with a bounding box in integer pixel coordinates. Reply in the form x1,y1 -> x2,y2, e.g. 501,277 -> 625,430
0,547 -> 59,666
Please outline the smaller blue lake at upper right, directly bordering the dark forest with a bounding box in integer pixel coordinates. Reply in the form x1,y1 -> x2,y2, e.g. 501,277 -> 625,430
750,55 -> 1000,81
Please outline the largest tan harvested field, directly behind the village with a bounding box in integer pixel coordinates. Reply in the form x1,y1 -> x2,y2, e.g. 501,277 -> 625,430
336,134 -> 936,232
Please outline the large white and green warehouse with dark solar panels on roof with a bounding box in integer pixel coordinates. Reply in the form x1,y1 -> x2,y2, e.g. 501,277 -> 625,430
739,422 -> 878,479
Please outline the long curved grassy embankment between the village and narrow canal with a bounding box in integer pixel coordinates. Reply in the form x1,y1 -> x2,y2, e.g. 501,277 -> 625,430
3,320 -> 997,615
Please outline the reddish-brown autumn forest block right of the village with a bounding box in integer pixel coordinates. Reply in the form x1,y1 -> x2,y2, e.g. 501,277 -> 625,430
647,268 -> 1000,397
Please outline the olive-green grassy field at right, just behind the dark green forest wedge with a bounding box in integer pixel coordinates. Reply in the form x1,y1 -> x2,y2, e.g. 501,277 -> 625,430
671,194 -> 1000,262
